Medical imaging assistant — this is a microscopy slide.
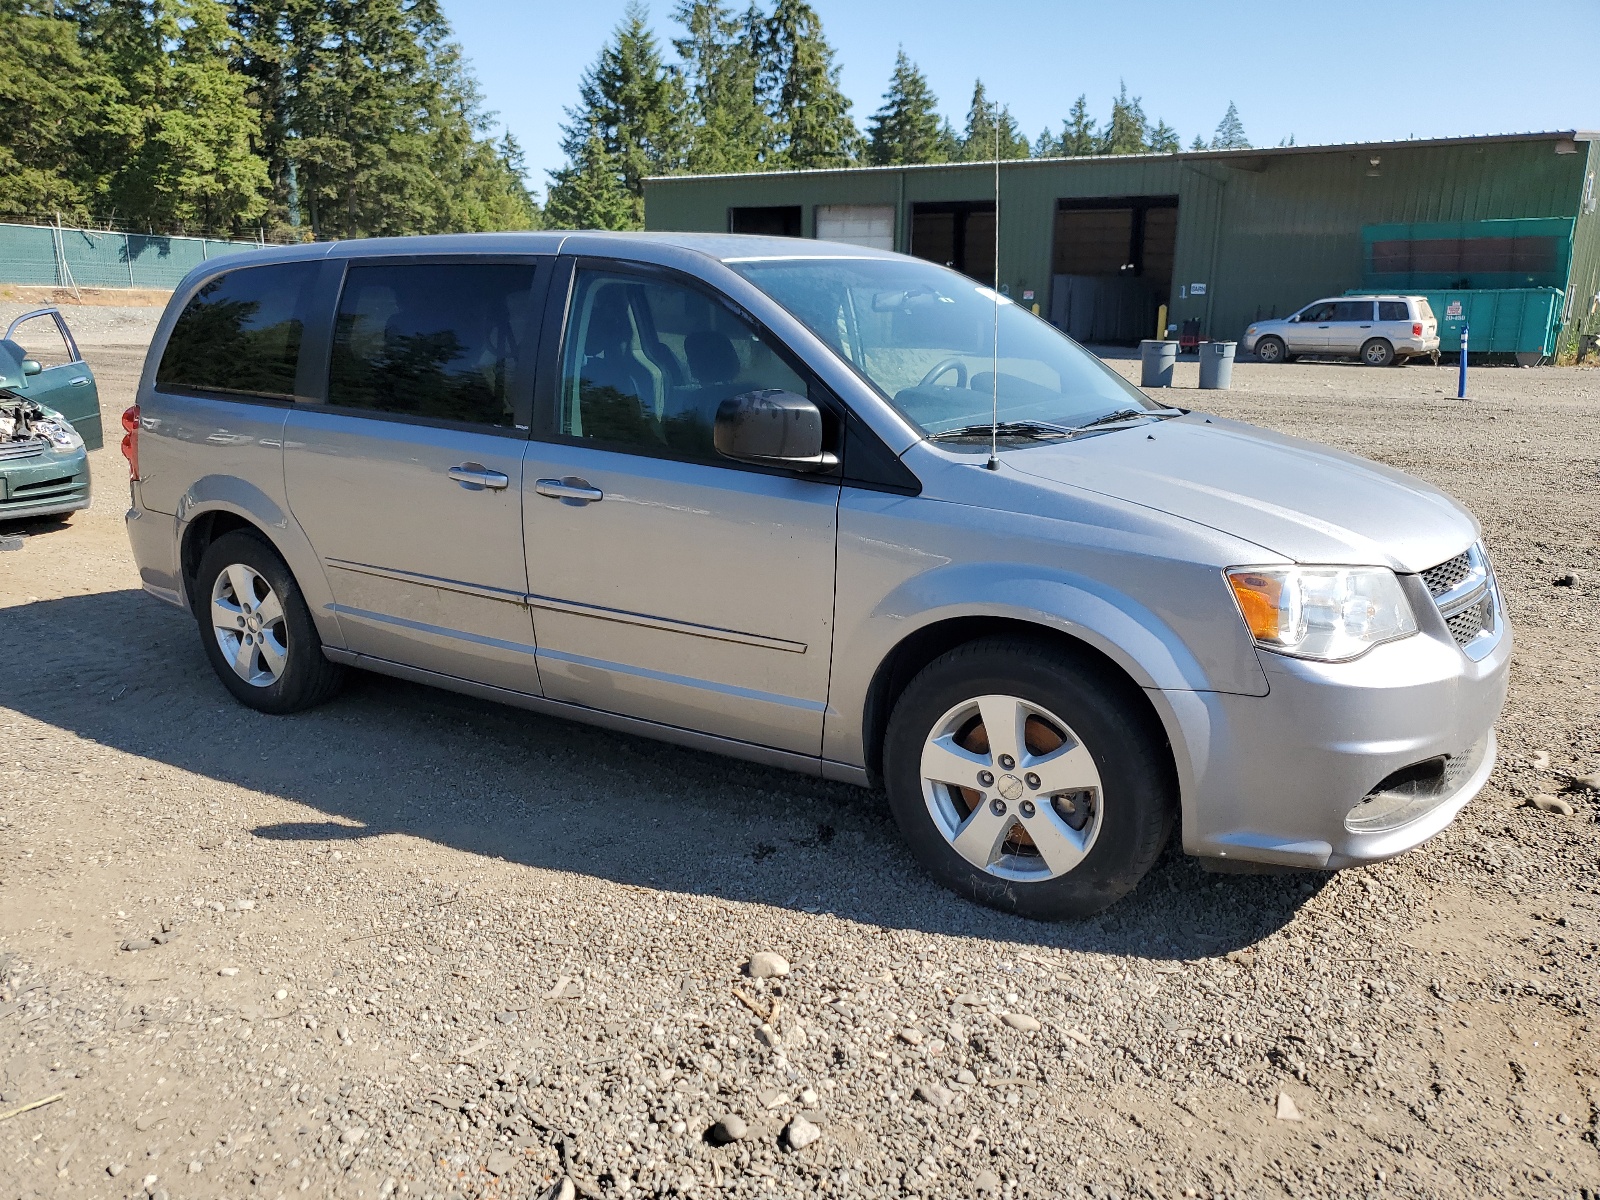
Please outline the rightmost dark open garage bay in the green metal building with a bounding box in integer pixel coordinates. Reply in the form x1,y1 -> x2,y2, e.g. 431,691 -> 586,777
1050,195 -> 1178,346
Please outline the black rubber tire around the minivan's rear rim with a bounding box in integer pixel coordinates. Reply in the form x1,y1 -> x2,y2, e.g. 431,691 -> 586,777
192,530 -> 344,715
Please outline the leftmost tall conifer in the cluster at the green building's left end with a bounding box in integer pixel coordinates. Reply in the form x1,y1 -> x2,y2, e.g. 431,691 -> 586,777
562,0 -> 688,229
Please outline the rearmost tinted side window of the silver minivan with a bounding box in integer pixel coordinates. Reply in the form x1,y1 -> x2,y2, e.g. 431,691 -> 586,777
155,262 -> 317,400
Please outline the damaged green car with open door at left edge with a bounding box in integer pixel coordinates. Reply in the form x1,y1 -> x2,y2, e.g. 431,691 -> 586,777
0,309 -> 104,522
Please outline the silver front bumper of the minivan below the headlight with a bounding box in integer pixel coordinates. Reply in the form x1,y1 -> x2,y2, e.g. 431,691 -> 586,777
1162,576 -> 1512,869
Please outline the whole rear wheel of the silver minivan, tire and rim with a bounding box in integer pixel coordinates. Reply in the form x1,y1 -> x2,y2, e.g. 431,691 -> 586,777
194,531 -> 344,714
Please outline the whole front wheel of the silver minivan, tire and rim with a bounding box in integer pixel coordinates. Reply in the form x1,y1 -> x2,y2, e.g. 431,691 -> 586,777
883,638 -> 1176,920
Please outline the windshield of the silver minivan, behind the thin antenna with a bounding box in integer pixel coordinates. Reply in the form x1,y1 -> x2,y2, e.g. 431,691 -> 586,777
728,258 -> 1158,440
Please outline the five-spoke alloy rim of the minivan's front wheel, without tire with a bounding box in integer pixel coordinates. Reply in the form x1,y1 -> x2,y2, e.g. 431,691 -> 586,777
922,696 -> 1102,882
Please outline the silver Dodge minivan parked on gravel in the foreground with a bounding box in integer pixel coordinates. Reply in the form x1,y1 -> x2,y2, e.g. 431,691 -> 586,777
123,234 -> 1512,918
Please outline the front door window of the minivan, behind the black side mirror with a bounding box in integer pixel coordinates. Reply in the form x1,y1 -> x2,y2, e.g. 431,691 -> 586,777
560,269 -> 810,462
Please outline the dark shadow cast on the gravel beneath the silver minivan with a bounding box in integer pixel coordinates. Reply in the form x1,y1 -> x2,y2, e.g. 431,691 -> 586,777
0,589 -> 1325,958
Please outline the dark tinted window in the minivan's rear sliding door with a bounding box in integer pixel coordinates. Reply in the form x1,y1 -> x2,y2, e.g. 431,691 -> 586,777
328,262 -> 538,427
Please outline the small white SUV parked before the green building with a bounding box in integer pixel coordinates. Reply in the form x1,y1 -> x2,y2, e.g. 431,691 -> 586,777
1245,296 -> 1438,366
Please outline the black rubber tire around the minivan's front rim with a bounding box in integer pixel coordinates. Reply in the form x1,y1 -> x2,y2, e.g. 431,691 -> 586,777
883,637 -> 1178,920
